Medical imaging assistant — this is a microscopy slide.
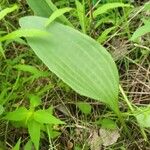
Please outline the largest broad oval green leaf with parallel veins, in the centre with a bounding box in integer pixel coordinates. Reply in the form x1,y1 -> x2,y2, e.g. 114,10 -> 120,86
20,16 -> 119,112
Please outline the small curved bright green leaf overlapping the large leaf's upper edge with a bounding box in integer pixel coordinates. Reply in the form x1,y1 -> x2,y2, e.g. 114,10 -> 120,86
45,8 -> 72,27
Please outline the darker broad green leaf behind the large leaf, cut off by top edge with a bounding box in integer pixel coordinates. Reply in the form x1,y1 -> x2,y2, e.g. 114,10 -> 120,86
27,0 -> 73,27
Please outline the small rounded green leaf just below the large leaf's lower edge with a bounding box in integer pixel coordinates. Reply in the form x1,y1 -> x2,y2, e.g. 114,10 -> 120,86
76,102 -> 92,115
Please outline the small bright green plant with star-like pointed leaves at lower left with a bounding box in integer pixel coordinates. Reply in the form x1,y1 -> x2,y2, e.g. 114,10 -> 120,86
4,95 -> 64,150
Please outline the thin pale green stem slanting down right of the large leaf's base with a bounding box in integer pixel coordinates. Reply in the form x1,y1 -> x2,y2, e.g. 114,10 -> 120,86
119,85 -> 148,141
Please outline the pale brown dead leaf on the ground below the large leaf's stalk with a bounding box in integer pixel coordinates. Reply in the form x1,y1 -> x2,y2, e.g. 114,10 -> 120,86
99,128 -> 120,146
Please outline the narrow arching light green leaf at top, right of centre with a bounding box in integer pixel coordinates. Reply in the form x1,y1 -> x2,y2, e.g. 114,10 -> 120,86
93,3 -> 131,18
